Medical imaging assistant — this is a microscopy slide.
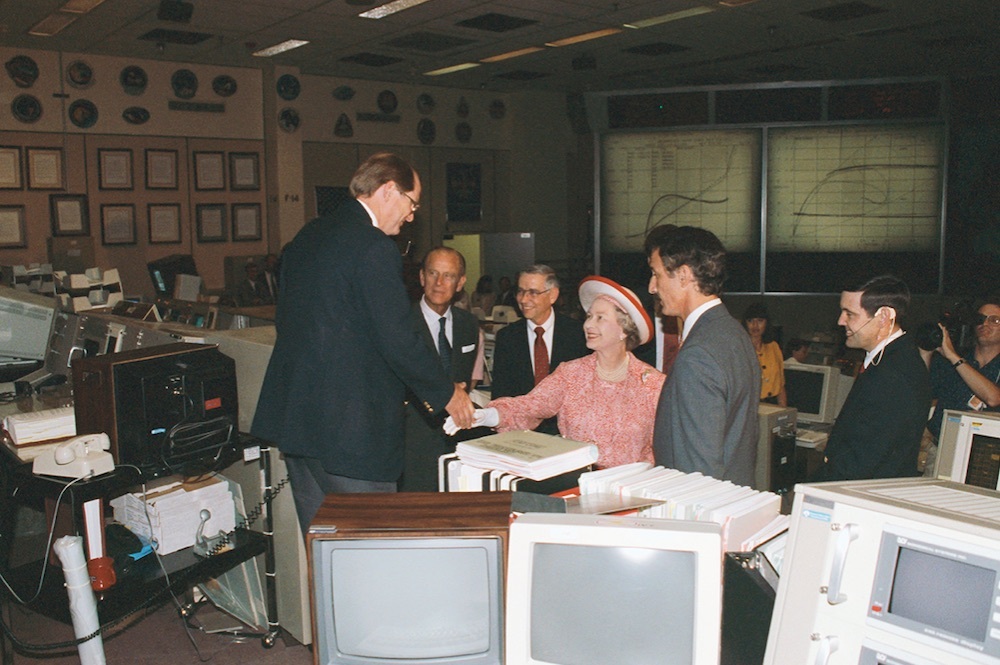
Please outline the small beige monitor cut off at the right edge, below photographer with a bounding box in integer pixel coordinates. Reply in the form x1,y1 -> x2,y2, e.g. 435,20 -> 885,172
934,409 -> 1000,490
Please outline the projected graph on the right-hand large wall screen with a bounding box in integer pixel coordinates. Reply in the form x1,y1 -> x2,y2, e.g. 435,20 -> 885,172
767,126 -> 944,252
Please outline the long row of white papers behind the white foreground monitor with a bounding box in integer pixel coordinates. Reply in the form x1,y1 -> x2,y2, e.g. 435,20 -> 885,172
580,462 -> 781,552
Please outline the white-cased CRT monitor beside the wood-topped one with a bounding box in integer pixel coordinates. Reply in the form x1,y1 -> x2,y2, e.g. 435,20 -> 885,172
506,513 -> 722,665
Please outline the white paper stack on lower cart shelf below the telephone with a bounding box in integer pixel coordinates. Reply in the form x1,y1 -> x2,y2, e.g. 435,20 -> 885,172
111,476 -> 236,554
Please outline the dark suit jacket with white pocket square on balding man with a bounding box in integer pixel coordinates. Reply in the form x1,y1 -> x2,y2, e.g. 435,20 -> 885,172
399,302 -> 480,492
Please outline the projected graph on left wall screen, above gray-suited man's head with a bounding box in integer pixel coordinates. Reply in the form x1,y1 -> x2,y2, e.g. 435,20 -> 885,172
601,129 -> 761,252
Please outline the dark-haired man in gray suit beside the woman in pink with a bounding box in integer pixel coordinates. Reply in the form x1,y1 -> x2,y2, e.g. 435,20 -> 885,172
646,224 -> 760,485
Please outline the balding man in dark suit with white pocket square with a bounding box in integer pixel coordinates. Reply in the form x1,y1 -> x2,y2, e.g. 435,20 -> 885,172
399,247 -> 491,492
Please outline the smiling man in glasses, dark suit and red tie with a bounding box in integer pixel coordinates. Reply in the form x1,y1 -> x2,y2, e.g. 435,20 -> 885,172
490,265 -> 590,434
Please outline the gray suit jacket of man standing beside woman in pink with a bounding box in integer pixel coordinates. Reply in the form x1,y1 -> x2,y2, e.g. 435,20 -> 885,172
653,305 -> 760,485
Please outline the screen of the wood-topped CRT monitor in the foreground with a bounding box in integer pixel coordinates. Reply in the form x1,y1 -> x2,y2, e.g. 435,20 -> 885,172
314,538 -> 503,663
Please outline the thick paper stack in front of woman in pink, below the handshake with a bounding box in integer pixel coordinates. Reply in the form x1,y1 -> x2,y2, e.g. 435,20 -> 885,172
455,431 -> 597,480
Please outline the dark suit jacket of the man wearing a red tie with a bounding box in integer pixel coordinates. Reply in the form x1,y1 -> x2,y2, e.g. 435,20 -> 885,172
490,314 -> 590,434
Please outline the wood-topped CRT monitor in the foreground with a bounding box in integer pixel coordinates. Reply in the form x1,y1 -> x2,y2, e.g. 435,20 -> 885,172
306,492 -> 511,665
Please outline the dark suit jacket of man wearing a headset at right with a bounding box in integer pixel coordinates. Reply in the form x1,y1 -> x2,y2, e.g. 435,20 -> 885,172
810,335 -> 931,481
